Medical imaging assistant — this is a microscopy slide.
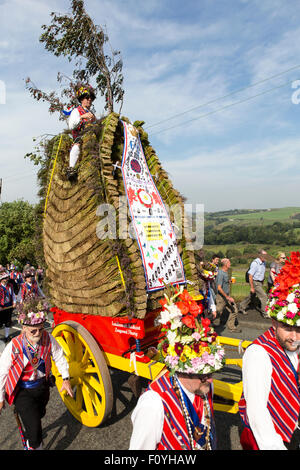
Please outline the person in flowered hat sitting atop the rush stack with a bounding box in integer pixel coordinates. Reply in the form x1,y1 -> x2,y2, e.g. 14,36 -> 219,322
67,85 -> 96,180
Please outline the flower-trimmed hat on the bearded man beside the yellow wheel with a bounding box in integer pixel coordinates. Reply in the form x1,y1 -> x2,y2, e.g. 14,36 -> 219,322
17,297 -> 50,326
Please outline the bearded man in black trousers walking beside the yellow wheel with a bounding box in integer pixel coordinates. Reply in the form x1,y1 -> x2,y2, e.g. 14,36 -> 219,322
0,299 -> 73,450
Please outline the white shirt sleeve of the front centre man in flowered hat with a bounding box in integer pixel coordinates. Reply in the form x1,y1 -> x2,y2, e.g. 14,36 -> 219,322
129,390 -> 164,450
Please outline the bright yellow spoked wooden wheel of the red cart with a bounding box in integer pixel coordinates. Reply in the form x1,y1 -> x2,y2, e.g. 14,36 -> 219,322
52,321 -> 113,427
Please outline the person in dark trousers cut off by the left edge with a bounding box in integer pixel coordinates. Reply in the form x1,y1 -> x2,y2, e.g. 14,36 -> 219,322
0,271 -> 16,343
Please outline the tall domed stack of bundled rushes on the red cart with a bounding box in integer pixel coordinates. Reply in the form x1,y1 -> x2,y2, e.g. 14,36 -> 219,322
43,113 -> 199,318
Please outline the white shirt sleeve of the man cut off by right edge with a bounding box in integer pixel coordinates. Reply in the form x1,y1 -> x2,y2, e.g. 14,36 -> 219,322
242,344 -> 286,450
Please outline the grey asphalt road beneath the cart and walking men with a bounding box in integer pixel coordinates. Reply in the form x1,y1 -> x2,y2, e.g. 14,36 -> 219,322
0,311 -> 270,451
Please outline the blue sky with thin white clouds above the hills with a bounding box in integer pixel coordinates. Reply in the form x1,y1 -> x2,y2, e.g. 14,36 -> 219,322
0,0 -> 300,211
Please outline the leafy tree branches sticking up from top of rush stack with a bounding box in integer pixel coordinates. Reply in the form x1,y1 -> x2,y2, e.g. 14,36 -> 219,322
26,0 -> 124,118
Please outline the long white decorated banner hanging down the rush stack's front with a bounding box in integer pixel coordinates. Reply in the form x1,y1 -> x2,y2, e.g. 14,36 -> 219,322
122,121 -> 186,292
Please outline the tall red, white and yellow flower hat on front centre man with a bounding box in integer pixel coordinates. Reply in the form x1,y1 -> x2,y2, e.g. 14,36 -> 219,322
158,287 -> 225,375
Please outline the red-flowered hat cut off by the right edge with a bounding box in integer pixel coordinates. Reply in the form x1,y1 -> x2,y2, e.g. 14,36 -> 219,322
266,251 -> 300,326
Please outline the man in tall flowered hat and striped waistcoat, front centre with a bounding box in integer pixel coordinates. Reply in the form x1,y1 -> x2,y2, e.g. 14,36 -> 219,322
130,284 -> 225,450
